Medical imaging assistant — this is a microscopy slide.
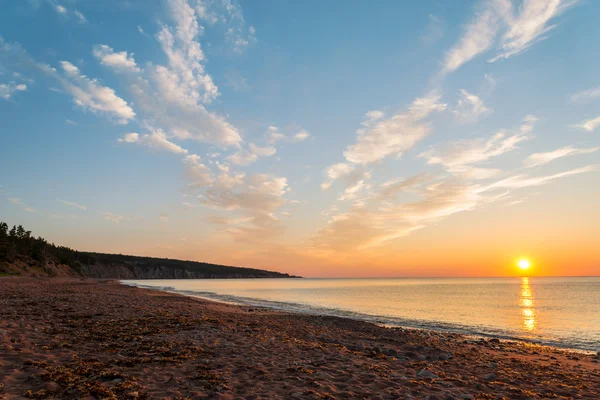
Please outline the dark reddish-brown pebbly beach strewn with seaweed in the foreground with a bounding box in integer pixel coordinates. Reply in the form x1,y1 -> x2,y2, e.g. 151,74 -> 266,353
0,278 -> 600,400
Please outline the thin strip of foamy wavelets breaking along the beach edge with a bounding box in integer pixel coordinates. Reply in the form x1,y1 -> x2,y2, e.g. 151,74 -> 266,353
119,281 -> 597,354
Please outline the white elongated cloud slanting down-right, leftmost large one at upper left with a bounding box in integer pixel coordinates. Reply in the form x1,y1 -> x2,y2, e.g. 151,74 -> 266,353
56,61 -> 135,124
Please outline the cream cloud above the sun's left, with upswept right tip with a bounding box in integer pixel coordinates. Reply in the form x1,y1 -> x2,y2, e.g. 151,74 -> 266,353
419,115 -> 537,179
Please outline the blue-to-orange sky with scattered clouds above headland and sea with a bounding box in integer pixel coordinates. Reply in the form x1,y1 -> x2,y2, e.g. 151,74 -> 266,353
0,0 -> 600,277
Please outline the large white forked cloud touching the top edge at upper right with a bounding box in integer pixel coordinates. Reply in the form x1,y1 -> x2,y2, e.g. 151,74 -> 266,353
443,0 -> 577,73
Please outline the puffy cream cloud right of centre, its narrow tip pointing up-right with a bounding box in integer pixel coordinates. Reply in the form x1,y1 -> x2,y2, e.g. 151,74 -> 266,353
344,93 -> 446,165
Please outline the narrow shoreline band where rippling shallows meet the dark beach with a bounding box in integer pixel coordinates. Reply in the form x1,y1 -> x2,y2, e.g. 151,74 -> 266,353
119,280 -> 600,355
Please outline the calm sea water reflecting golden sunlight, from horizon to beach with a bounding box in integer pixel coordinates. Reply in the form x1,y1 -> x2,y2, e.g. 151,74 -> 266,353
123,278 -> 600,351
